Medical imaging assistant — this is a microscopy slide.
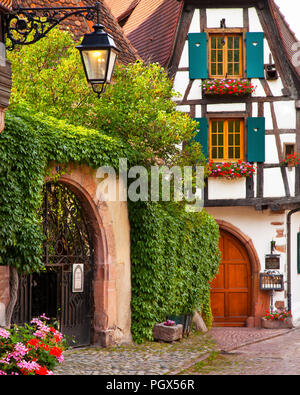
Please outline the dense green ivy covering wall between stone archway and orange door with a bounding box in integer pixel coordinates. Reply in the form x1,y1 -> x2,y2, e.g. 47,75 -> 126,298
129,202 -> 220,342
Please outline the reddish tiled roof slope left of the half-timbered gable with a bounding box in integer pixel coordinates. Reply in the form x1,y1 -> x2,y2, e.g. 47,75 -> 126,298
107,0 -> 183,66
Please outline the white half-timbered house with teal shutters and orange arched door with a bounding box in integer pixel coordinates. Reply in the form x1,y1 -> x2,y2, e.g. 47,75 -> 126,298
108,0 -> 300,326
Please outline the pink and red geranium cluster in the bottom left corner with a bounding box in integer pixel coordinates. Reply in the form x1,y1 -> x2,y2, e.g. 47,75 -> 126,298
0,315 -> 67,375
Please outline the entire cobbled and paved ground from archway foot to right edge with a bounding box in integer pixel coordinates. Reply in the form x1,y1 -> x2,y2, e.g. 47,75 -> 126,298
54,328 -> 300,375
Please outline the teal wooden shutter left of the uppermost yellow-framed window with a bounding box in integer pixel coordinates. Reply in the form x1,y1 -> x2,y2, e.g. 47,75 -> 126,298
188,33 -> 207,80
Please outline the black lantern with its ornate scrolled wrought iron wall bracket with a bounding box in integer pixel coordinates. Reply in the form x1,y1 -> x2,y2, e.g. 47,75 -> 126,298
5,2 -> 119,97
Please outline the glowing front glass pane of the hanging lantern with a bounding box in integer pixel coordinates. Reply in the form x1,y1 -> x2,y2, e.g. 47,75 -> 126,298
82,49 -> 109,81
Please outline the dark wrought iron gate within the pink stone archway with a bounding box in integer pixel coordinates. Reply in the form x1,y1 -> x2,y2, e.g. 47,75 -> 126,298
13,182 -> 93,346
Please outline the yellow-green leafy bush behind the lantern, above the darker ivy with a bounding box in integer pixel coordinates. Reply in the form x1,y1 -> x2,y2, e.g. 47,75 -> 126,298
10,29 -> 205,165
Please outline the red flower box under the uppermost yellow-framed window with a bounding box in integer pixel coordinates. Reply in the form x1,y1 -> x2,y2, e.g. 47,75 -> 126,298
202,78 -> 256,96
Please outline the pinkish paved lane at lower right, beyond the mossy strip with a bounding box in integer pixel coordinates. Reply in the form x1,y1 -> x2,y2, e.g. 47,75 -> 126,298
182,329 -> 300,376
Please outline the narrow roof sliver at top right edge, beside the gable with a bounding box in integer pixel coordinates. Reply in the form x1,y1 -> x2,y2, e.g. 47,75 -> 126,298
269,0 -> 300,77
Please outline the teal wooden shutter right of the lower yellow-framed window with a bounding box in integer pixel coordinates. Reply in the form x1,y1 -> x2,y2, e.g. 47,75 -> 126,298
247,117 -> 265,162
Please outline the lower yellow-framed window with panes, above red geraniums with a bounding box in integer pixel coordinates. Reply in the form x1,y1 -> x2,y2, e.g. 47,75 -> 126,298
210,119 -> 244,162
